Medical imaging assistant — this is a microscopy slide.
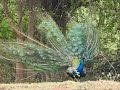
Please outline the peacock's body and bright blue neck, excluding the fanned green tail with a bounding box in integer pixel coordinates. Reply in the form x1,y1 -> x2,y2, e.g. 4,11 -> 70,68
66,57 -> 86,79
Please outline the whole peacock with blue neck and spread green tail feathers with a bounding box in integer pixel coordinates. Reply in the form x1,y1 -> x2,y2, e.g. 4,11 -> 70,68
0,11 -> 98,79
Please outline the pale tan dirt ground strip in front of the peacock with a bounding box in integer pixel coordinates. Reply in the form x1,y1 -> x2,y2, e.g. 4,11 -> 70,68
0,80 -> 120,90
